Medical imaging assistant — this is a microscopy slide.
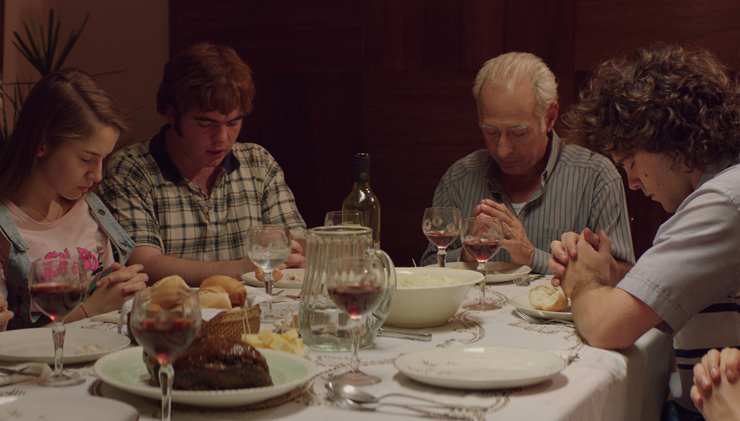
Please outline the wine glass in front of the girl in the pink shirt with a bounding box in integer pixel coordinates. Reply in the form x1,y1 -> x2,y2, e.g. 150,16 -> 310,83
28,254 -> 88,387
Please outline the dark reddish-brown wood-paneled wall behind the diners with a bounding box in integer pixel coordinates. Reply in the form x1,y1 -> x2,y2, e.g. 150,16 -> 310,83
170,0 -> 740,266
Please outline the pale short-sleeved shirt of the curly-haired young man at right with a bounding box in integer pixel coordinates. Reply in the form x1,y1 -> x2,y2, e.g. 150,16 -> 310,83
617,159 -> 740,411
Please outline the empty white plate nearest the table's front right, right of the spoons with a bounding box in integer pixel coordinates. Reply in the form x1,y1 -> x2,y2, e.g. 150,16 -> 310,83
395,346 -> 566,389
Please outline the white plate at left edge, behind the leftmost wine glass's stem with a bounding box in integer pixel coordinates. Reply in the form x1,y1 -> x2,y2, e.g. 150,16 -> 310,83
0,328 -> 131,367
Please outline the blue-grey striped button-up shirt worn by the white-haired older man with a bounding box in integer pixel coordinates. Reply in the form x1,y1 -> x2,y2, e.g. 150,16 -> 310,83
421,131 -> 635,273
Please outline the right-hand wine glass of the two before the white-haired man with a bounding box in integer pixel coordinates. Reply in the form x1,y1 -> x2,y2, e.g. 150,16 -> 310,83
460,215 -> 504,310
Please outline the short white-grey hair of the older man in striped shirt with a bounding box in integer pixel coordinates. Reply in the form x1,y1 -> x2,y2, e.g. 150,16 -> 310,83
473,52 -> 558,131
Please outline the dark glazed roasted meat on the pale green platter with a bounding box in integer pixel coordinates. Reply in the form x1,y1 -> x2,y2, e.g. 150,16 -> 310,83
144,336 -> 273,390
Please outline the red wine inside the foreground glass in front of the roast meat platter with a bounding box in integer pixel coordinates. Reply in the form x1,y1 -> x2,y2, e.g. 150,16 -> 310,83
132,318 -> 198,365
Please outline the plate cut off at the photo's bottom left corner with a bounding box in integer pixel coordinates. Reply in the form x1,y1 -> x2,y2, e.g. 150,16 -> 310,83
0,395 -> 139,421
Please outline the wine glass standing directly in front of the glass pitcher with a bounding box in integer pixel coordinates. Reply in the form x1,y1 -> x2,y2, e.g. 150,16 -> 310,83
326,257 -> 388,386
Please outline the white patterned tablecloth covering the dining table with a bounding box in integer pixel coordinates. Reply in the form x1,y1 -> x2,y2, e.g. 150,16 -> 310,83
0,274 -> 672,421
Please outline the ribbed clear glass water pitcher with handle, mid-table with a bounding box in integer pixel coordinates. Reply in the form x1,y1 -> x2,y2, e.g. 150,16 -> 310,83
298,225 -> 396,351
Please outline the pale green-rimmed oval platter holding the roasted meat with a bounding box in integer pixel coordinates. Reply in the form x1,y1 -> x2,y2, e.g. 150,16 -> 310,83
95,347 -> 316,407
